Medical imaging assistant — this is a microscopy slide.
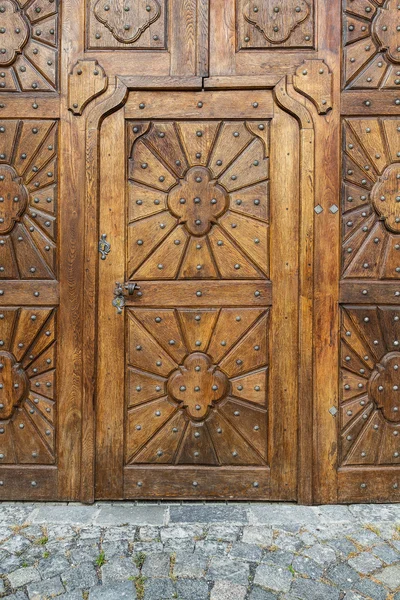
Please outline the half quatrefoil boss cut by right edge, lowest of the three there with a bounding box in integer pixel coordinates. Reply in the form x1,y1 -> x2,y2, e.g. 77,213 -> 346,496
369,352 -> 400,423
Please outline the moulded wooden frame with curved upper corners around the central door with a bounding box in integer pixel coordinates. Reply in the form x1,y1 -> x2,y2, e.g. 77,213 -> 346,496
81,75 -> 328,504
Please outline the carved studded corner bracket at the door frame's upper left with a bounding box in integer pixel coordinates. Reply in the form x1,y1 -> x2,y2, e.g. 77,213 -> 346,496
68,59 -> 108,115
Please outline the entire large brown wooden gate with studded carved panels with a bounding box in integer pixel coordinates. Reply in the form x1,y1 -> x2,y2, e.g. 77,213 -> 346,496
0,0 -> 400,503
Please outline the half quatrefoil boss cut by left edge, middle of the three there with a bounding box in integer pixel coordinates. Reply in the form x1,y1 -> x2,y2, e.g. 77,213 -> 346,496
0,164 -> 28,235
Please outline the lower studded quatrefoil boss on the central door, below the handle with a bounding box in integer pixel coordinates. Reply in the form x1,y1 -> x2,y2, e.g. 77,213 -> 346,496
168,352 -> 229,421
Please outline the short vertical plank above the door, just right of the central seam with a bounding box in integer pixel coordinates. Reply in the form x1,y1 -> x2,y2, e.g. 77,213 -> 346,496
210,0 -> 236,76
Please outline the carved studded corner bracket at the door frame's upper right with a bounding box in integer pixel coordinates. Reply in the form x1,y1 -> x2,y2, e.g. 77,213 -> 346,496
293,60 -> 332,115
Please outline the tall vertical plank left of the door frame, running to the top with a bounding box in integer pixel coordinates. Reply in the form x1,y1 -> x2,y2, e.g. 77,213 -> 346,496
58,0 -> 85,500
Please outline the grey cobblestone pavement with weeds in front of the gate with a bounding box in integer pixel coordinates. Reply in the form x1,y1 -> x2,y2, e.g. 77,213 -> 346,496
0,503 -> 400,600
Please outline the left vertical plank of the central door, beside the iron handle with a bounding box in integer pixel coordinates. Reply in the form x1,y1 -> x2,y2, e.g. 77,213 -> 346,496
95,110 -> 126,499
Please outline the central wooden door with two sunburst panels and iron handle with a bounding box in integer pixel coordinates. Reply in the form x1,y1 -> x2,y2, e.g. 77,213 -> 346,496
96,90 -> 304,500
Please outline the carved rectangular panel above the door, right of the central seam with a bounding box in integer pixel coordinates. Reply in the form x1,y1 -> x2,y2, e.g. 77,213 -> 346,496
237,0 -> 314,50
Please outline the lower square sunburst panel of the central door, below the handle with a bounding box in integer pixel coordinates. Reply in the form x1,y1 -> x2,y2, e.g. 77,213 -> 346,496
126,308 -> 269,465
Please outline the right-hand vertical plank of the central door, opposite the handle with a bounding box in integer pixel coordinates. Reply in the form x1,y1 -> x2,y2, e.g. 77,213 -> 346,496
269,107 -> 300,500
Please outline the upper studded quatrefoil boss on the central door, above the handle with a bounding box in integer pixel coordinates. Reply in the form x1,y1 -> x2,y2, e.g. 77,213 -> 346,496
168,167 -> 228,236
